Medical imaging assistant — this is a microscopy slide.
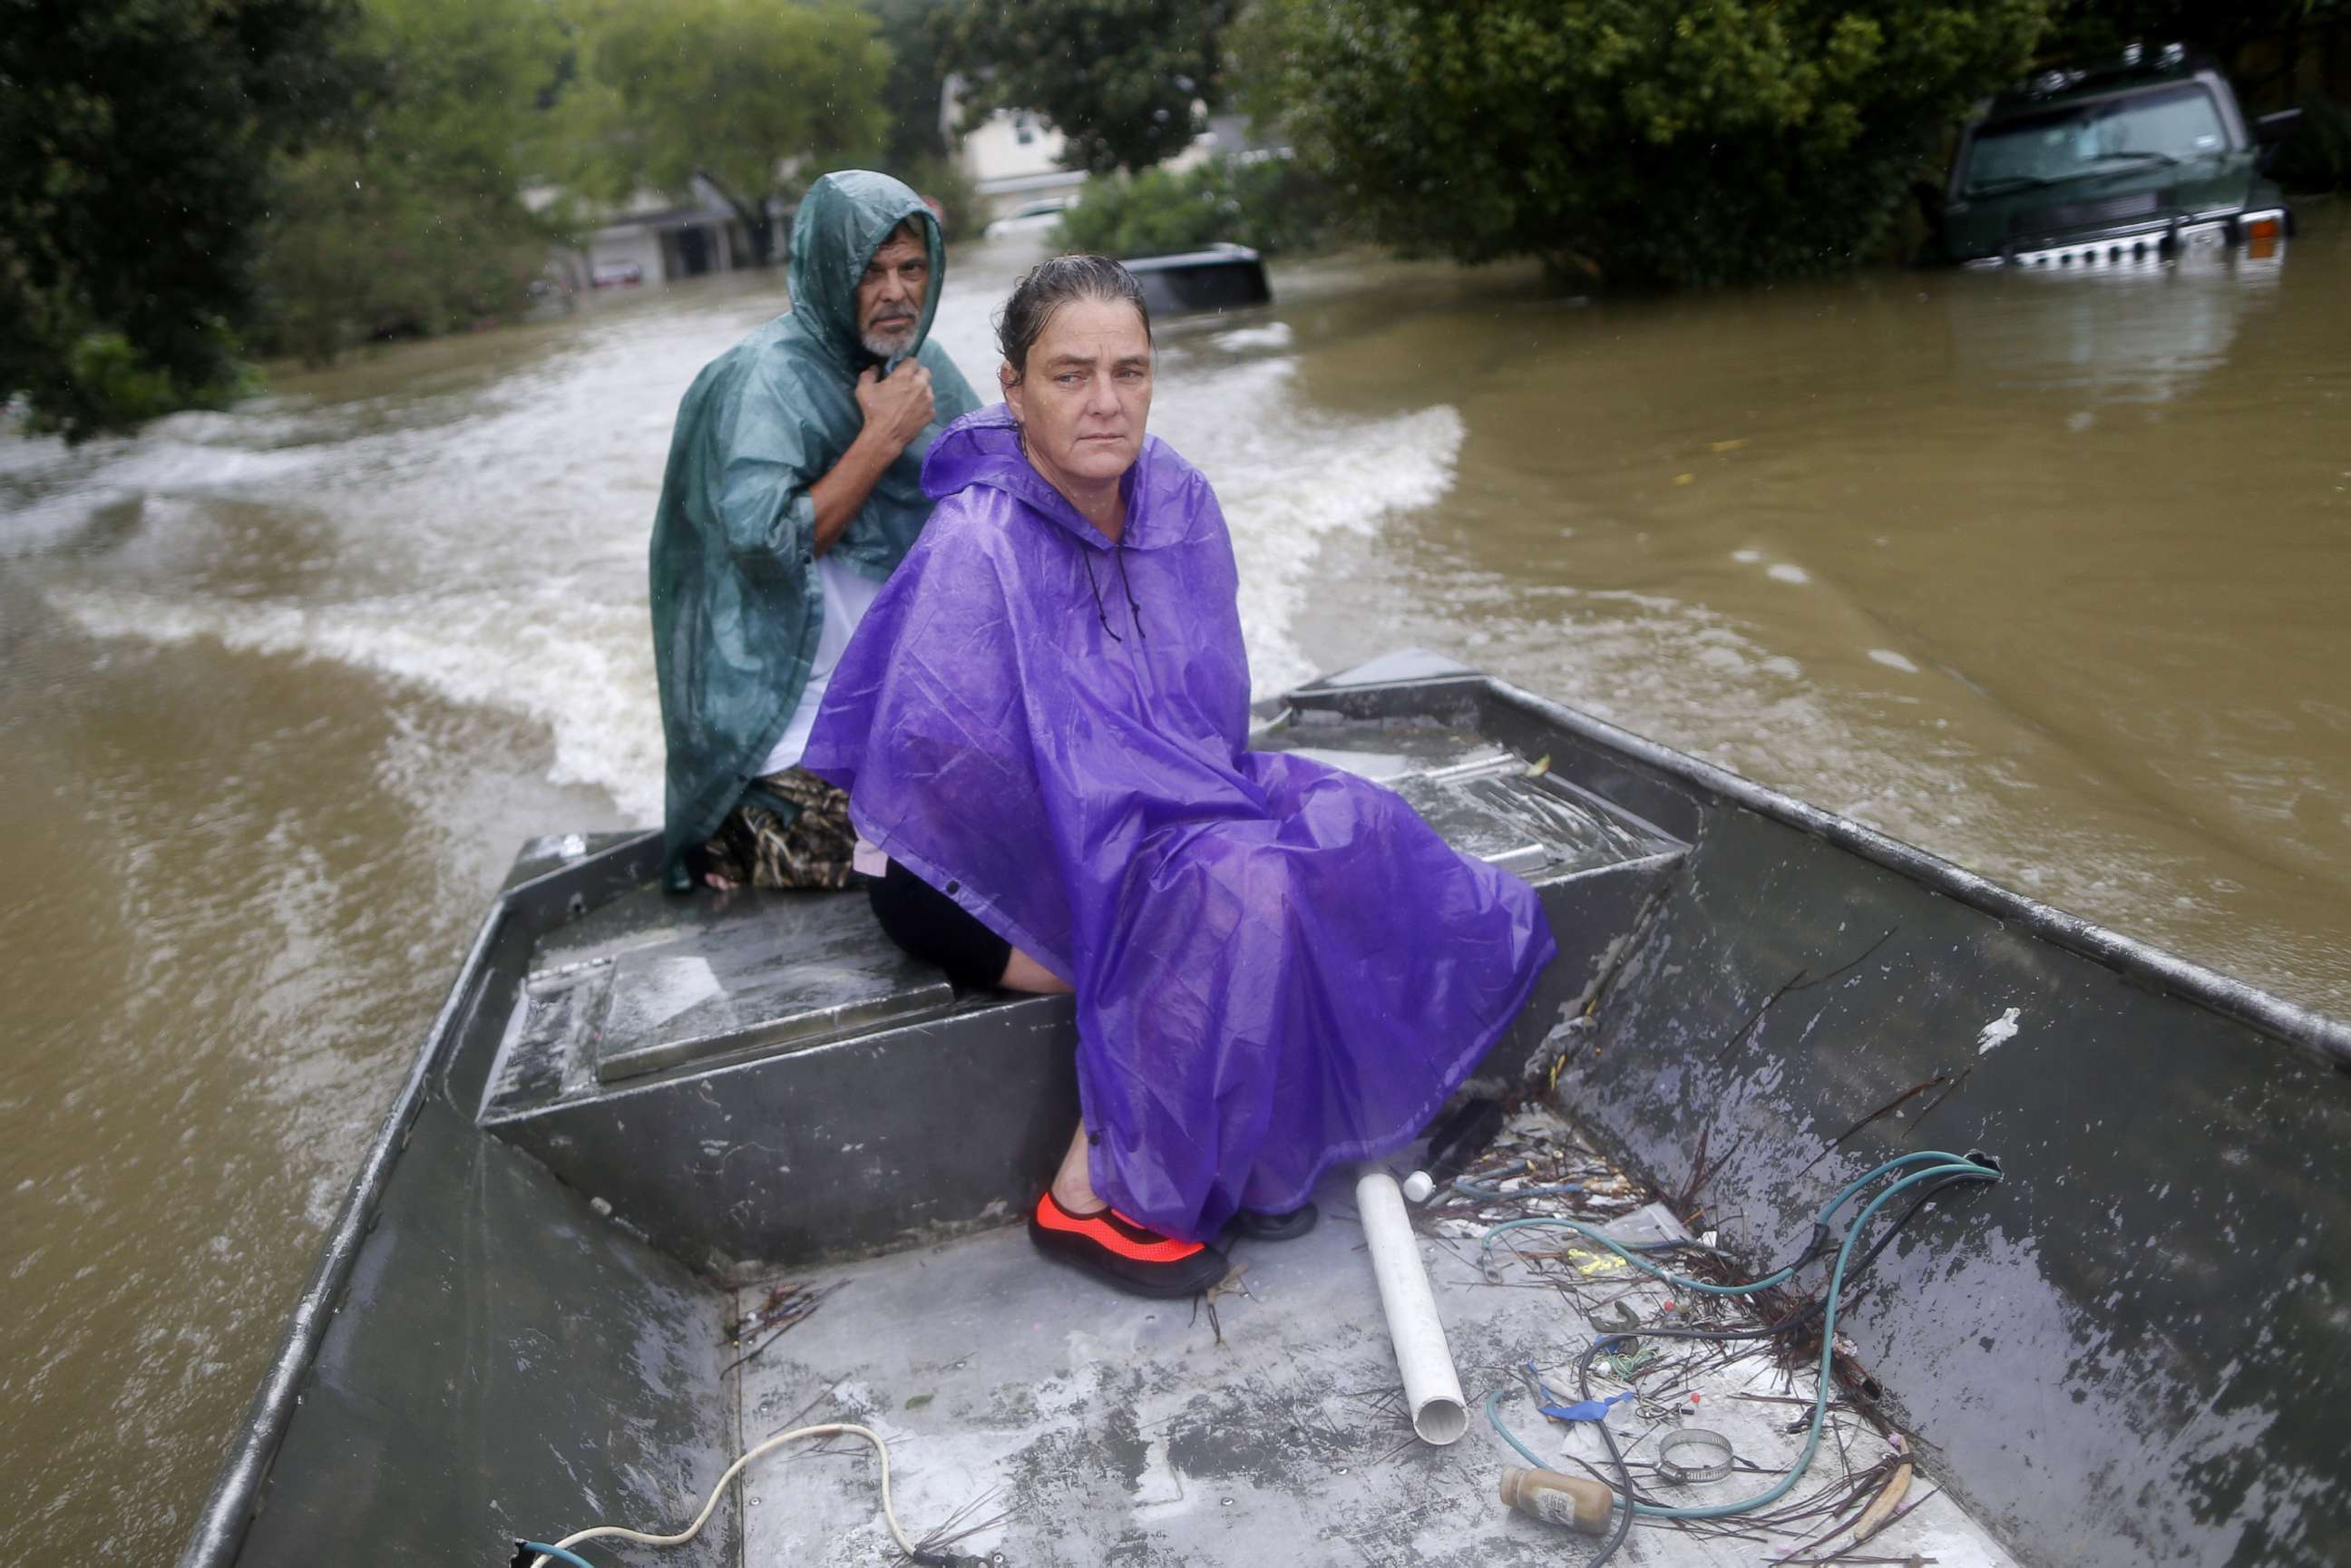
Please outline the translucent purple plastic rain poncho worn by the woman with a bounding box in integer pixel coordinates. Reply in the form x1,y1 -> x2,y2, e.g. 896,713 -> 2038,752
802,404 -> 1556,1239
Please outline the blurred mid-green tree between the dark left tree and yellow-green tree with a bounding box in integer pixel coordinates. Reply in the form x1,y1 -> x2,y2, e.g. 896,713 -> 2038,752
261,0 -> 567,362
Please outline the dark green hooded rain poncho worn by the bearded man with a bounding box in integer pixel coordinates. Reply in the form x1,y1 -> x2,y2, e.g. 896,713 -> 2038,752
651,170 -> 978,891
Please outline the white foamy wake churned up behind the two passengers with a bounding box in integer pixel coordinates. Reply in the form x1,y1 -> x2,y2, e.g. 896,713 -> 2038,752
18,268 -> 1410,821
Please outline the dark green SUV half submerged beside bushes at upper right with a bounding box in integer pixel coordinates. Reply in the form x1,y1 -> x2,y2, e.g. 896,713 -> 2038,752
1939,44 -> 2299,266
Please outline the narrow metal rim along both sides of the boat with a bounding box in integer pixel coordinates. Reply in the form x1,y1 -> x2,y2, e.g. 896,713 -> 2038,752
179,670 -> 2351,1568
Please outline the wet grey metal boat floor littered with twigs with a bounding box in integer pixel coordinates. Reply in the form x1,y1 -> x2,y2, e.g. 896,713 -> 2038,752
738,1112 -> 2013,1568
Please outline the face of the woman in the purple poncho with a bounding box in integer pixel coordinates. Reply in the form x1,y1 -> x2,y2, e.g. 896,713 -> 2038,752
1000,298 -> 1152,484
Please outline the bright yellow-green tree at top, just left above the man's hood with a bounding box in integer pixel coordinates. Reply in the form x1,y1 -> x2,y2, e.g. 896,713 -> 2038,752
569,0 -> 891,266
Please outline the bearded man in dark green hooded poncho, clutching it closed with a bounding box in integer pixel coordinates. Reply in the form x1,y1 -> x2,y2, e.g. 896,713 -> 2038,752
651,170 -> 978,893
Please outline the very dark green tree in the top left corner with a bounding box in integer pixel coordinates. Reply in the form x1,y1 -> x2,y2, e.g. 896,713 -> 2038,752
0,0 -> 353,440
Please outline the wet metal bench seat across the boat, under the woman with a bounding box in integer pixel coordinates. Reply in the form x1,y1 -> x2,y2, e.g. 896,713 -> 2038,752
480,677 -> 1688,1279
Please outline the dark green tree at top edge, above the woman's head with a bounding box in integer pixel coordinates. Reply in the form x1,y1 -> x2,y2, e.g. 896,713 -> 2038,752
941,0 -> 1236,174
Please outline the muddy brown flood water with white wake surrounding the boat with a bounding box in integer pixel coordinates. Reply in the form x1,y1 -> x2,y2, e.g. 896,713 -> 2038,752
14,207 -> 2351,1561
